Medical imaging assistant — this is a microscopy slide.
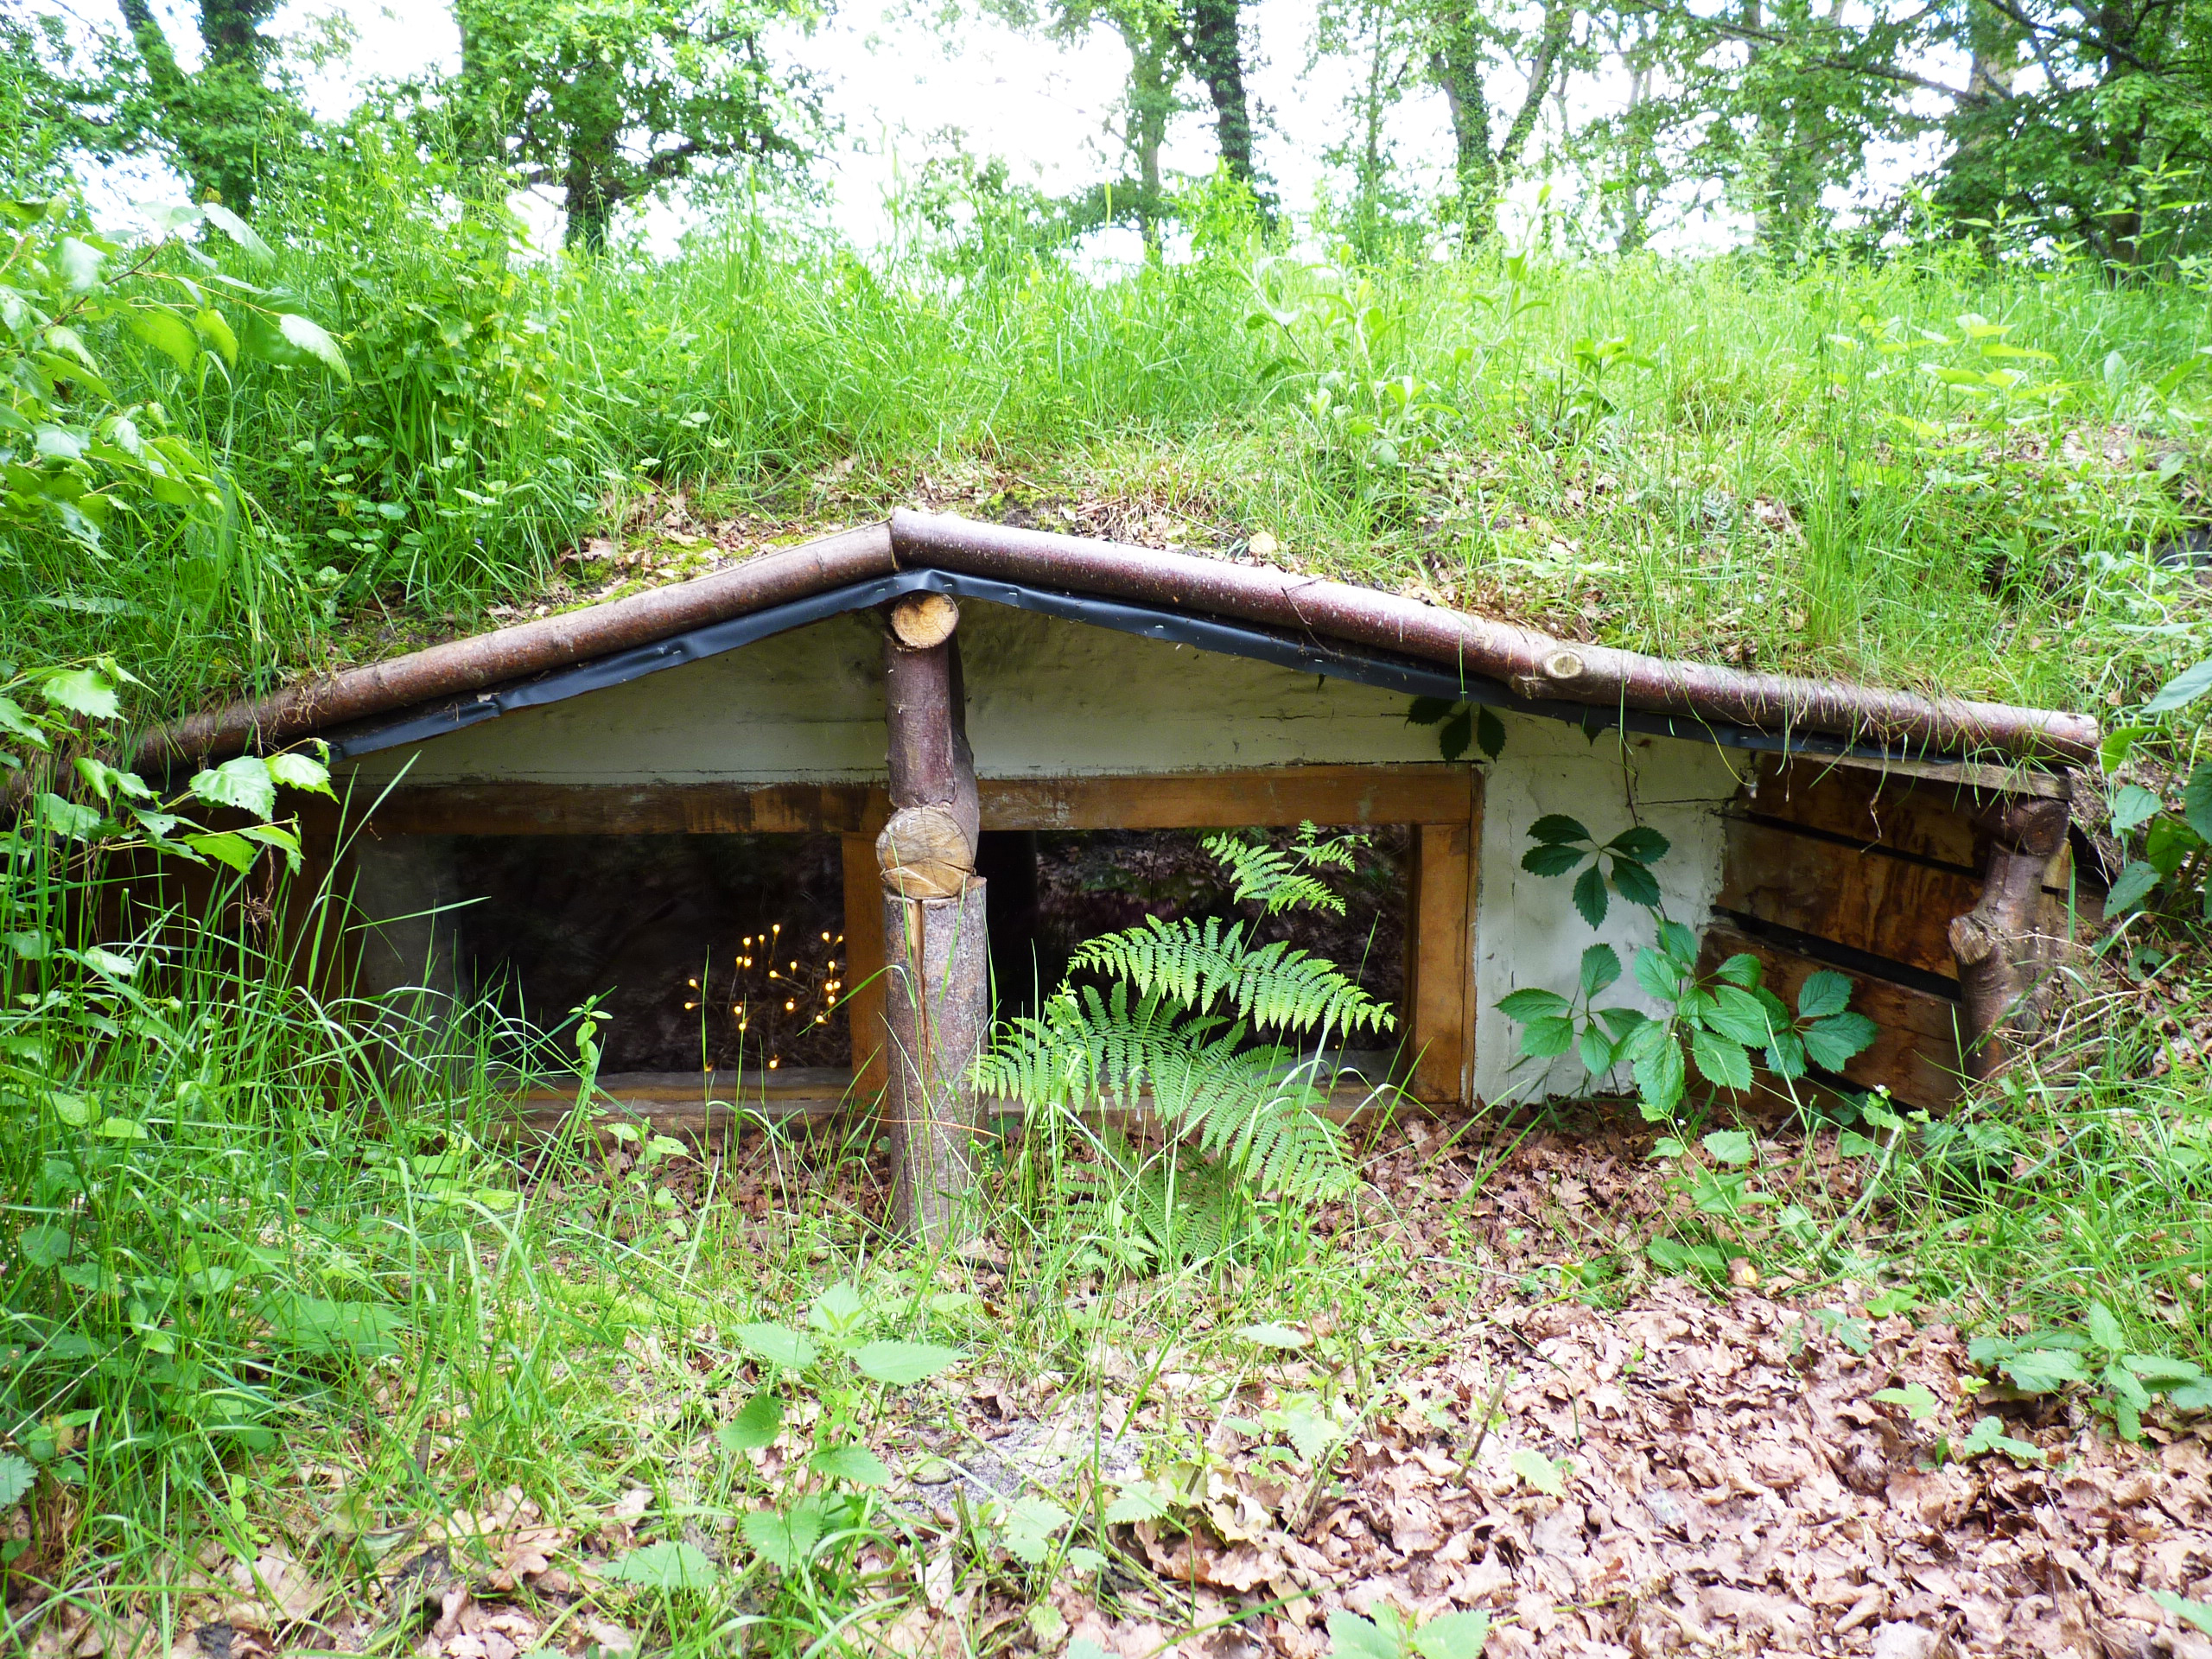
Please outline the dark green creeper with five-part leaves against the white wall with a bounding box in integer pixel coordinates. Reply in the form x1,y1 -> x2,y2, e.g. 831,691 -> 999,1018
1497,814 -> 1876,1122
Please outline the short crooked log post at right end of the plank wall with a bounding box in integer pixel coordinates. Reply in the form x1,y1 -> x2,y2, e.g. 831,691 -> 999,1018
1951,798 -> 2070,1079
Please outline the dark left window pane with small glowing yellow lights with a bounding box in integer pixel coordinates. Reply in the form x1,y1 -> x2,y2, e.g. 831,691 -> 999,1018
454,836 -> 852,1073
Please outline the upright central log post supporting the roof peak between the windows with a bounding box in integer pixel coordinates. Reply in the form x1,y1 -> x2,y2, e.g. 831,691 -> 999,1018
876,593 -> 991,1243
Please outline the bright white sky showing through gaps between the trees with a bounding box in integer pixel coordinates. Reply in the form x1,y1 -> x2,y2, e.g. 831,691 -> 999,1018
60,0 -> 1920,261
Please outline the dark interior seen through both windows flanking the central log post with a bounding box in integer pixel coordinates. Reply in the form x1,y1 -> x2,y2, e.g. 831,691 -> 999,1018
451,827 -> 1409,1073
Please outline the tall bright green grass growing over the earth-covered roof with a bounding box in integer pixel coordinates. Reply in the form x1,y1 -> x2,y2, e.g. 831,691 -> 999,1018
0,152 -> 2205,725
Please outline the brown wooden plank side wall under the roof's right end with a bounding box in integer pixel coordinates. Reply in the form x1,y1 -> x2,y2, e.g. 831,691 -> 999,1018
1703,754 -> 2073,1110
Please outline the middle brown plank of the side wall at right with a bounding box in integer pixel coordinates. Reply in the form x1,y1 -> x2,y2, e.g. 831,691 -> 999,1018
1714,818 -> 1982,980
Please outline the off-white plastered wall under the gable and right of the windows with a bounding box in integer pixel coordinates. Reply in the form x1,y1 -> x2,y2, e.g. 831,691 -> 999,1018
340,601 -> 1741,1099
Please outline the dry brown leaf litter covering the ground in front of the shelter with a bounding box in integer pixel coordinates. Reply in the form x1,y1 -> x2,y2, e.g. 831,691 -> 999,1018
55,1123 -> 2212,1659
